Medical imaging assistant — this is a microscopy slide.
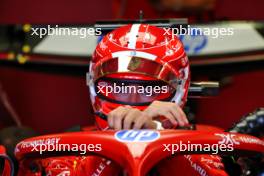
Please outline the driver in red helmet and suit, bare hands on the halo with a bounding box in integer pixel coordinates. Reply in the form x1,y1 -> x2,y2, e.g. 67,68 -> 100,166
20,24 -> 228,176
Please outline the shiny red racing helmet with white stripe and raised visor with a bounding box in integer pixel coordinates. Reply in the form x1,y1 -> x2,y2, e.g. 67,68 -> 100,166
87,24 -> 190,128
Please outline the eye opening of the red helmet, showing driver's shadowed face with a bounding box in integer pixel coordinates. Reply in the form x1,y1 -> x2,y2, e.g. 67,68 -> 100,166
95,77 -> 176,106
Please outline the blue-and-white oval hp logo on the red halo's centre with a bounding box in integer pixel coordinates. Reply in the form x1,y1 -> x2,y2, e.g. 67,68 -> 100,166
115,130 -> 160,142
